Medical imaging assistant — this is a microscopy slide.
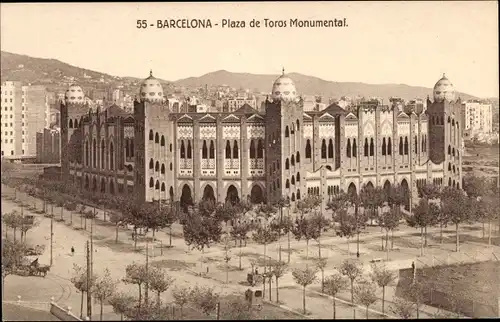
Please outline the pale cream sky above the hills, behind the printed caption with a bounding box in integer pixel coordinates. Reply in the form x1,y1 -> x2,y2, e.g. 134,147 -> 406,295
0,1 -> 499,97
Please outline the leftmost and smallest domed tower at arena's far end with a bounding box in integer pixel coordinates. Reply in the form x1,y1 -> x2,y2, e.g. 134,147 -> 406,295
59,84 -> 89,179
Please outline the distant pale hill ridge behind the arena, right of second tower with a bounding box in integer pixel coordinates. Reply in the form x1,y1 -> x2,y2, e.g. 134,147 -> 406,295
175,70 -> 476,99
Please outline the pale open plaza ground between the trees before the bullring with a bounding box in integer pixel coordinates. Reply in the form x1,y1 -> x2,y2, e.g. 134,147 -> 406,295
2,186 -> 500,319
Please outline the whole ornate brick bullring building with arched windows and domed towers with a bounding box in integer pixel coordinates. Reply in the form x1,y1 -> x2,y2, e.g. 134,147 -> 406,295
61,74 -> 462,210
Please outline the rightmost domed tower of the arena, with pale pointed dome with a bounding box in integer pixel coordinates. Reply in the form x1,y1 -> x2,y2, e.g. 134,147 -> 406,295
426,74 -> 462,187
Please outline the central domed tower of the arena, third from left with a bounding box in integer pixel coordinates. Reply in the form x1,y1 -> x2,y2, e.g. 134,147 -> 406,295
265,69 -> 305,203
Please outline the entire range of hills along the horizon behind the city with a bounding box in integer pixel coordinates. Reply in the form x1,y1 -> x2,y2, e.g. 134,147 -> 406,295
0,51 -> 482,100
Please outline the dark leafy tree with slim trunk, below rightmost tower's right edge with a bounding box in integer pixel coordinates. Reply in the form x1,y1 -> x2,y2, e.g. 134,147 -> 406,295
441,187 -> 472,252
